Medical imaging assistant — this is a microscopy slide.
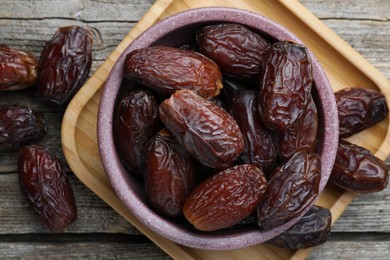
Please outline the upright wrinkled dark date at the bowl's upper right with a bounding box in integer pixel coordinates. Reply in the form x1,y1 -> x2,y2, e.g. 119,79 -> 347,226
258,42 -> 313,132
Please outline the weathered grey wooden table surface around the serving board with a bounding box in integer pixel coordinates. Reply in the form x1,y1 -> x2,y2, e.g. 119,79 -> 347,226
0,0 -> 390,259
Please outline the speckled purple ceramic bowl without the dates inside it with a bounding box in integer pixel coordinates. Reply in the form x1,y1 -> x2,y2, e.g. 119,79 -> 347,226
98,7 -> 338,250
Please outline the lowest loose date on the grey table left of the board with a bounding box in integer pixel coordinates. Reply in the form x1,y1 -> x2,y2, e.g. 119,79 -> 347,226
18,145 -> 77,231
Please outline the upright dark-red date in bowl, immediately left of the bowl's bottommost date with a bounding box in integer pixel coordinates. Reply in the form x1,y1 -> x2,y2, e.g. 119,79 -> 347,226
144,130 -> 196,217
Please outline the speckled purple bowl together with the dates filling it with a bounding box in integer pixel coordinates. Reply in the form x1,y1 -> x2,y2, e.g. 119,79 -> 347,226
98,7 -> 339,250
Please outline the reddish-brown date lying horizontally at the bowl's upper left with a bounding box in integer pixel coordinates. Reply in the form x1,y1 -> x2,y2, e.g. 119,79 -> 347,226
124,46 -> 222,98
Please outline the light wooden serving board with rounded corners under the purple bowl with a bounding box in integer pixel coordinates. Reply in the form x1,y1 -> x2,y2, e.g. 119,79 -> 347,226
61,0 -> 390,259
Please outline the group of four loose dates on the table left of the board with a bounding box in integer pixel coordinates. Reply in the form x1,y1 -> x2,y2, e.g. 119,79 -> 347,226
0,26 -> 92,231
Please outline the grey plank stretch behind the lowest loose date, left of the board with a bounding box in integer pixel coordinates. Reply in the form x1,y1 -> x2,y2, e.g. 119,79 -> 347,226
0,174 -> 140,235
